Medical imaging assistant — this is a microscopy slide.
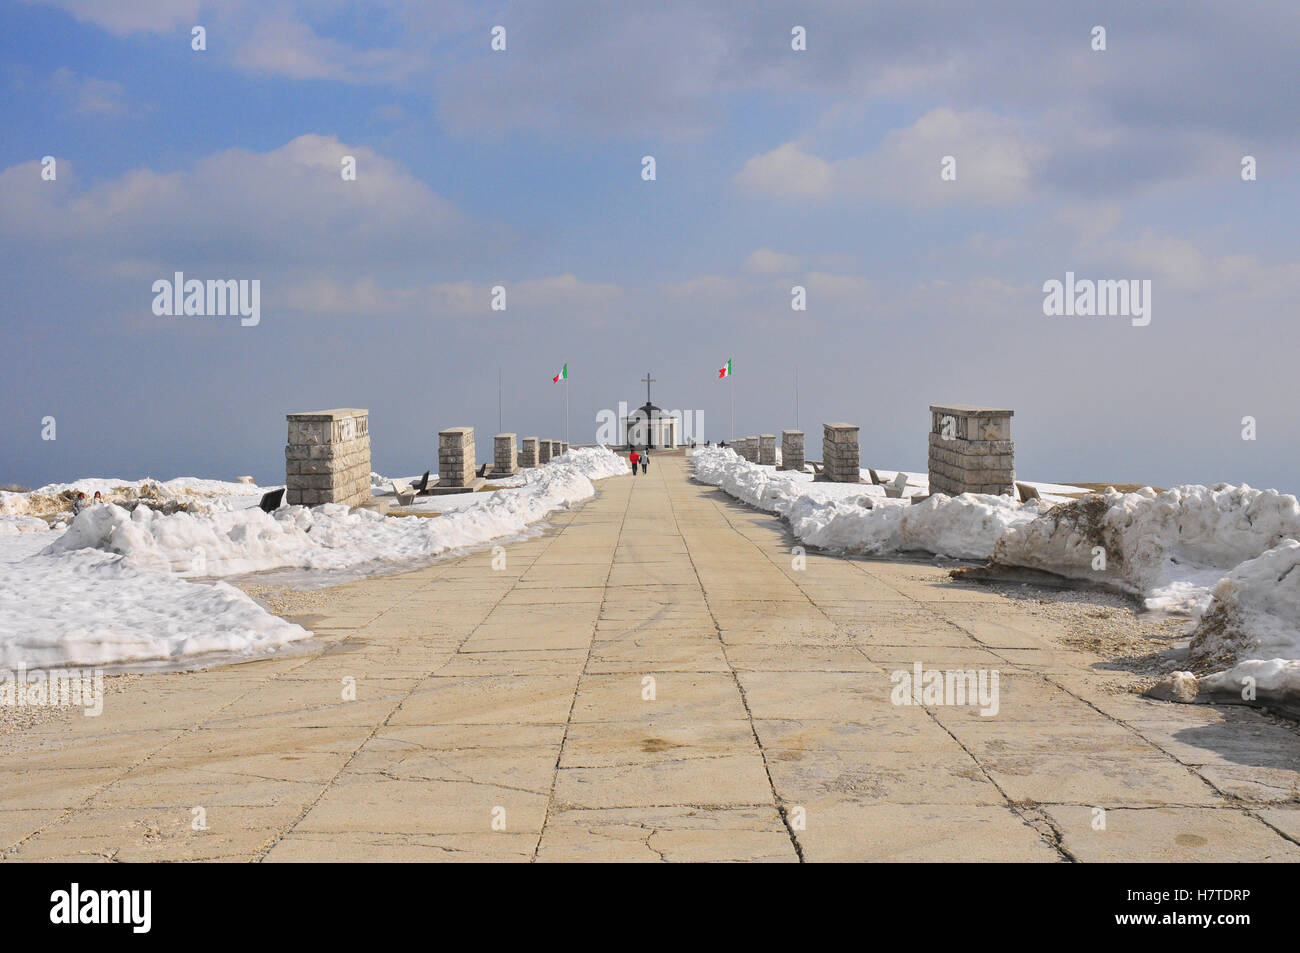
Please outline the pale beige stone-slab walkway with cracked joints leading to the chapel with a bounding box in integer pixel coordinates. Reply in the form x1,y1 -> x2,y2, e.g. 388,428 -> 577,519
0,455 -> 1300,861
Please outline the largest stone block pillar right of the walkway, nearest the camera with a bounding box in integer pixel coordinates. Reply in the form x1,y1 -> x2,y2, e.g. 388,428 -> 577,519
930,404 -> 1015,497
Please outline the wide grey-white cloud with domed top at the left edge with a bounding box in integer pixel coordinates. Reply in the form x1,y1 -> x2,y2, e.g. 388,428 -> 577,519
0,134 -> 483,269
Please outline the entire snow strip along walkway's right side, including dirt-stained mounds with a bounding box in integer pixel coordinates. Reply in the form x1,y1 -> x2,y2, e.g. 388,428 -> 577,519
693,447 -> 1300,701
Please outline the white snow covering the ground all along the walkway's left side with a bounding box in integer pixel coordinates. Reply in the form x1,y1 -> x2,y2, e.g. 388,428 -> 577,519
0,449 -> 628,670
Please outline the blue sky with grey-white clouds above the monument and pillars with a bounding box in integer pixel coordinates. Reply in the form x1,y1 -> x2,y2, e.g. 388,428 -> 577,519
0,0 -> 1300,493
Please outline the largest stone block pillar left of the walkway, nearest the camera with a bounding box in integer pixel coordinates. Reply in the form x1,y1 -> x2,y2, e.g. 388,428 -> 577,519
285,408 -> 371,506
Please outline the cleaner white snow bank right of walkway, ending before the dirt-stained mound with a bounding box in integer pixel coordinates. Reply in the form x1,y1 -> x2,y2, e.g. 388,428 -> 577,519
692,447 -> 1040,559
